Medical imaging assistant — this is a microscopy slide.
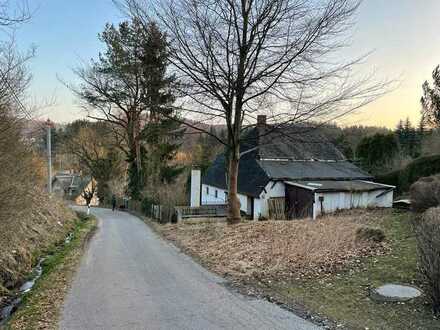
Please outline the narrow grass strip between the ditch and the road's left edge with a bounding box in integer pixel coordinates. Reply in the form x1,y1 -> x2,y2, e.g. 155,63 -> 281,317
5,214 -> 96,330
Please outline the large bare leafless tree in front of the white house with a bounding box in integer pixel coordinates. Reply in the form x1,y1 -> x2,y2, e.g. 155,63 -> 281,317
119,0 -> 384,223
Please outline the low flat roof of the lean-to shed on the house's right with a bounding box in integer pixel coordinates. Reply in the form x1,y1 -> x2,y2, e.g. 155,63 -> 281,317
285,180 -> 395,192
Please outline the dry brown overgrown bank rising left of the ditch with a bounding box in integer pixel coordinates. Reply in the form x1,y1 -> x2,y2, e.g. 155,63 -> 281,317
0,115 -> 74,306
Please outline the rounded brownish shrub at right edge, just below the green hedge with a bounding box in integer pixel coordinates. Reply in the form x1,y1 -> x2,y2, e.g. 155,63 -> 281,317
410,176 -> 440,212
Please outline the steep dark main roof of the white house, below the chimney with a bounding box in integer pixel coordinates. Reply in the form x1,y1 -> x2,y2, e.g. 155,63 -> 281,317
202,125 -> 372,197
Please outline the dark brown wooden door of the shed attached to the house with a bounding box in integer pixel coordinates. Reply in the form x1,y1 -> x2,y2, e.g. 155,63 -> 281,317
286,184 -> 314,219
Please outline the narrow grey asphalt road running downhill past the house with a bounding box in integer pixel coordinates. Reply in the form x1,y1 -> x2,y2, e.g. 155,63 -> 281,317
60,209 -> 317,330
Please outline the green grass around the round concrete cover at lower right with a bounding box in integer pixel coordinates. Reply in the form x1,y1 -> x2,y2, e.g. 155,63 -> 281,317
271,213 -> 440,329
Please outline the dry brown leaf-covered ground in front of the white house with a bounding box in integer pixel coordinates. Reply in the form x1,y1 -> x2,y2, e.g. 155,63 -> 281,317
159,210 -> 386,278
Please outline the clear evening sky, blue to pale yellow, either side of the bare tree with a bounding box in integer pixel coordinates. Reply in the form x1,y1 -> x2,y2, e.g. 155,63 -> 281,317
16,0 -> 440,127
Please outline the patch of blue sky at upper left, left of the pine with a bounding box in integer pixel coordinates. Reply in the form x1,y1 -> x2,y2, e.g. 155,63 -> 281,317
16,0 -> 123,122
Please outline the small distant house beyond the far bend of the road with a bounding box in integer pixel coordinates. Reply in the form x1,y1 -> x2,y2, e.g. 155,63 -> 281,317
52,172 -> 99,206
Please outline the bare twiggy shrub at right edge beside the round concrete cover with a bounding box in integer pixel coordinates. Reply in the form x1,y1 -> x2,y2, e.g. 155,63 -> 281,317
417,207 -> 440,315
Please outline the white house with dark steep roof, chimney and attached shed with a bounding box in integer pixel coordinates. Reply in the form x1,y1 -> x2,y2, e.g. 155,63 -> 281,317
191,116 -> 395,219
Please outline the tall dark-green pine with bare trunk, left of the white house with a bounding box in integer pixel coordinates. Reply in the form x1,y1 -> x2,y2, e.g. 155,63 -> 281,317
75,19 -> 179,200
